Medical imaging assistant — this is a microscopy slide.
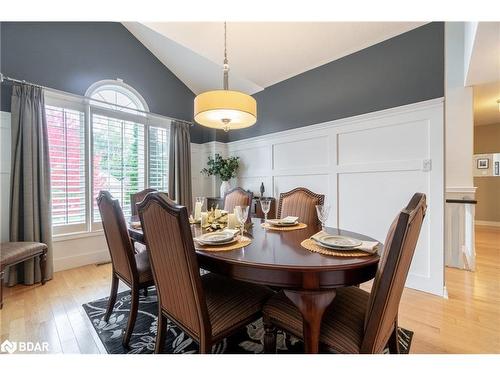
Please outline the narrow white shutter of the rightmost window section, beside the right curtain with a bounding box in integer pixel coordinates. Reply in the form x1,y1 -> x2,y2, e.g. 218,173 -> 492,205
149,126 -> 170,191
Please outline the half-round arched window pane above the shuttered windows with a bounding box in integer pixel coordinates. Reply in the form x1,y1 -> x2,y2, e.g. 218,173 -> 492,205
85,80 -> 149,114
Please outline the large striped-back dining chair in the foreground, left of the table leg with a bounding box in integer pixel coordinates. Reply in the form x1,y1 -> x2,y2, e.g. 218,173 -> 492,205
138,193 -> 272,353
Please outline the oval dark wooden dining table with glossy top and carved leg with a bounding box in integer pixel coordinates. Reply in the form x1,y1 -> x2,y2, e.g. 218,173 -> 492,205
129,218 -> 382,353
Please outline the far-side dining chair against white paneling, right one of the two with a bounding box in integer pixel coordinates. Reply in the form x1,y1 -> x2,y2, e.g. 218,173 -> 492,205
278,187 -> 325,225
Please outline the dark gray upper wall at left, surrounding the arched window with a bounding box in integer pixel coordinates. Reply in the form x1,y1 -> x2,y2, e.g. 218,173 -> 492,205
0,22 -> 214,143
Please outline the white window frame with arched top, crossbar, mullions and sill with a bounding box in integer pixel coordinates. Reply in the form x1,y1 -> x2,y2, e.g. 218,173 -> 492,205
45,80 -> 172,241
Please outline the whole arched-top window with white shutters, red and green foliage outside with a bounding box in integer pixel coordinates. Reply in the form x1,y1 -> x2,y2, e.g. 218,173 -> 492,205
45,82 -> 174,235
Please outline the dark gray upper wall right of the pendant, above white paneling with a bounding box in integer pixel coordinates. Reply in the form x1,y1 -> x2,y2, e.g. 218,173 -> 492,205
224,22 -> 444,141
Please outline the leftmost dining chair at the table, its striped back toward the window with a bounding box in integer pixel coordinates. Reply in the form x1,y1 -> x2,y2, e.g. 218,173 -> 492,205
97,191 -> 154,346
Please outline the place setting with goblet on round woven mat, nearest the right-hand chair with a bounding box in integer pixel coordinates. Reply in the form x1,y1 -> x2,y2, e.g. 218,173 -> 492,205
300,205 -> 380,257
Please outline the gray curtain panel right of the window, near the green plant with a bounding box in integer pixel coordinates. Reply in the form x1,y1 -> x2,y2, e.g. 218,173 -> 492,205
168,121 -> 193,212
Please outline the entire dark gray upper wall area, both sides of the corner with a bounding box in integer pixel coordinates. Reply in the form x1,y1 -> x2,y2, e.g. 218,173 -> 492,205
0,22 -> 444,143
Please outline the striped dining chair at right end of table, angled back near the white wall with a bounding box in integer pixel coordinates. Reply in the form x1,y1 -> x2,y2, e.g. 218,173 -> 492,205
263,193 -> 427,354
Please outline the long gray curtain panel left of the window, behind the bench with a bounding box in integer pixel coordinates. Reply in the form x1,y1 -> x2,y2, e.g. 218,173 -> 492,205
6,85 -> 53,285
